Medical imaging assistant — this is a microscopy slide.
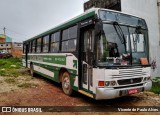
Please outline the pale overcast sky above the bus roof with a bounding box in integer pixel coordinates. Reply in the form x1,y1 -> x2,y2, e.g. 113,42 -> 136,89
0,0 -> 88,42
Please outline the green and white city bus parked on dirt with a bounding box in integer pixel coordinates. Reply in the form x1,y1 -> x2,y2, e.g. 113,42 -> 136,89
22,8 -> 152,100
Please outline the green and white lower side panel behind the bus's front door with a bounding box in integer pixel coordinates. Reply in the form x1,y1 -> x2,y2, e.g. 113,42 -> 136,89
28,53 -> 78,91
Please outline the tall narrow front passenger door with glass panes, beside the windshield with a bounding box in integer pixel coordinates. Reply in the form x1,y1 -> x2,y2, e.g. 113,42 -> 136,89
81,28 -> 94,93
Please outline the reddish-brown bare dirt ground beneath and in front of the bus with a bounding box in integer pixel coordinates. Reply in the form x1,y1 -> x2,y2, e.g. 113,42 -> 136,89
0,76 -> 160,115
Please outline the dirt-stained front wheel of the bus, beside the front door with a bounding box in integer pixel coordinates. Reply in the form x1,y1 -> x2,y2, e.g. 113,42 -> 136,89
62,72 -> 73,96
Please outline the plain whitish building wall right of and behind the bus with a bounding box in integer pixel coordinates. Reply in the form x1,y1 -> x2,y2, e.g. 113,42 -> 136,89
121,0 -> 160,77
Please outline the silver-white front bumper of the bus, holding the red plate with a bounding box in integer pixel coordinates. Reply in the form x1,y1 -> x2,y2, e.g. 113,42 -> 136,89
95,81 -> 152,100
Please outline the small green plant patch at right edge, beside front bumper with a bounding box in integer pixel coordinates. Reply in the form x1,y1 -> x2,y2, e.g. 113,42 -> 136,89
150,77 -> 160,94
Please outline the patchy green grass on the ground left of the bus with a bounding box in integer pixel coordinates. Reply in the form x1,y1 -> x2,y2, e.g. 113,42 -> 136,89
0,58 -> 38,88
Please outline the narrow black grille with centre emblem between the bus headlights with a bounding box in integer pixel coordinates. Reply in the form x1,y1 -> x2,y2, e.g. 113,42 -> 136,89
117,77 -> 143,85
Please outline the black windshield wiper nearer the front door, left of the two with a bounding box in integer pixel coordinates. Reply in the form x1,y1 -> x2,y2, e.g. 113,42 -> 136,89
113,22 -> 127,52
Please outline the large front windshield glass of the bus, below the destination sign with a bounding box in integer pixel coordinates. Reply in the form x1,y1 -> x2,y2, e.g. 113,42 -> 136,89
96,23 -> 148,66
